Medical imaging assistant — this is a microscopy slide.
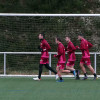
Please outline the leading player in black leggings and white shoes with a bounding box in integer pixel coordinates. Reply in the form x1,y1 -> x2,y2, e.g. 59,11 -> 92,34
33,33 -> 58,80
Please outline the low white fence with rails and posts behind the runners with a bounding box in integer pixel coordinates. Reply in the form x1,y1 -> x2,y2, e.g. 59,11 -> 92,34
0,52 -> 100,77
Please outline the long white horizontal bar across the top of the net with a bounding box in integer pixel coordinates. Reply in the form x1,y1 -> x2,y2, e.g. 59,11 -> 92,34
0,13 -> 100,17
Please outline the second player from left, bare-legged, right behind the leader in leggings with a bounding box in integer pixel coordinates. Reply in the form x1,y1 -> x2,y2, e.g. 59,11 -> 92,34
54,37 -> 71,82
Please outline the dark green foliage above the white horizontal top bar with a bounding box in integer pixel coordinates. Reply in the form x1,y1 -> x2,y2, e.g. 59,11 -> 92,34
0,0 -> 100,13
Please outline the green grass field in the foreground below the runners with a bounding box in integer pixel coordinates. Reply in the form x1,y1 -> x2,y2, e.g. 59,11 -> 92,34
0,77 -> 100,100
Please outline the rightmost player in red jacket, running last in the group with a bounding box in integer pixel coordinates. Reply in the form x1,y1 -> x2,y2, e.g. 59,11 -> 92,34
76,35 -> 97,80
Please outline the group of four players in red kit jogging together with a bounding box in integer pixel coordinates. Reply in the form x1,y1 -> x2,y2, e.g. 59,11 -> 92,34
33,33 -> 97,82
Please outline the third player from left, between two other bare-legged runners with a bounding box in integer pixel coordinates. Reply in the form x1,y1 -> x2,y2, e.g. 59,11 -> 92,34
65,37 -> 79,79
